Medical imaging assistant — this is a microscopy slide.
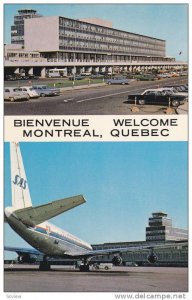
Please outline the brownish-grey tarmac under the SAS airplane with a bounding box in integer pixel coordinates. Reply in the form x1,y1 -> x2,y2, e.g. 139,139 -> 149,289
4,265 -> 188,292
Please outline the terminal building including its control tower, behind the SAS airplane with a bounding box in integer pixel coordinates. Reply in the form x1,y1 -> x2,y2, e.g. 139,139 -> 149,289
92,212 -> 188,266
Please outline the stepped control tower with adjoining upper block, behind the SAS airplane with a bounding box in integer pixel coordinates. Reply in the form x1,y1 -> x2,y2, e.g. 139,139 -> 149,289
146,212 -> 188,242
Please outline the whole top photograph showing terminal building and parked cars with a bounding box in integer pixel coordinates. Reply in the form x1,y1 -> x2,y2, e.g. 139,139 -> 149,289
3,3 -> 189,116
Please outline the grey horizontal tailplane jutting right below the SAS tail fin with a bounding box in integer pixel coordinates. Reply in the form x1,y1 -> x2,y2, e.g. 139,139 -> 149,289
14,195 -> 85,226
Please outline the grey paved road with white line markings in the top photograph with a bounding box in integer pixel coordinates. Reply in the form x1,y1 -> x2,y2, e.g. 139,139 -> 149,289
4,78 -> 186,115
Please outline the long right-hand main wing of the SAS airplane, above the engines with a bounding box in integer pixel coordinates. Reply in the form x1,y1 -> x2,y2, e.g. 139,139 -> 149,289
86,241 -> 188,257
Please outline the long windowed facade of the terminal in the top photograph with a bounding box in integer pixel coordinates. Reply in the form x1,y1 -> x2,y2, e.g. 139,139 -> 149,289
59,17 -> 166,58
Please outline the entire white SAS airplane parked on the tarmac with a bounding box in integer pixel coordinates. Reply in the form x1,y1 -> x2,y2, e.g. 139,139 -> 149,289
5,142 -> 186,271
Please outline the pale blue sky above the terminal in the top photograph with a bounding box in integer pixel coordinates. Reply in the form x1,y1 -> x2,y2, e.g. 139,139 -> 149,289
4,3 -> 188,61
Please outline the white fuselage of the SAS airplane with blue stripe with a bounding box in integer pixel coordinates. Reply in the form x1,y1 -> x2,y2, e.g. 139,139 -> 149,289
5,208 -> 92,257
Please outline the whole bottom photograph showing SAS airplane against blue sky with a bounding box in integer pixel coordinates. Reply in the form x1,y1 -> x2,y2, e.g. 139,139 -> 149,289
4,141 -> 188,292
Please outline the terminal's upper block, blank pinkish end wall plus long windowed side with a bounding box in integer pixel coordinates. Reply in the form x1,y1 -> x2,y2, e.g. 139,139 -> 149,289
24,16 -> 166,61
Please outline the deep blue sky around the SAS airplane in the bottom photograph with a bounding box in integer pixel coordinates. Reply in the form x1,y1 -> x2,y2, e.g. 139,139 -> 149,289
4,142 -> 188,258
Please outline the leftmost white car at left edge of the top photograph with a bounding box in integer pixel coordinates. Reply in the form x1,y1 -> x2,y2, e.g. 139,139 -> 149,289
4,87 -> 29,102
